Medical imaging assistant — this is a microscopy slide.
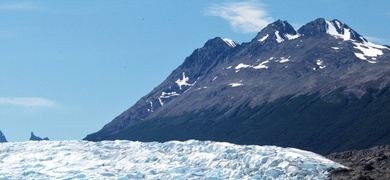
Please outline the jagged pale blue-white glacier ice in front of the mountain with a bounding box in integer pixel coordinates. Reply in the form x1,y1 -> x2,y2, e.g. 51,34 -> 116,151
0,140 -> 345,180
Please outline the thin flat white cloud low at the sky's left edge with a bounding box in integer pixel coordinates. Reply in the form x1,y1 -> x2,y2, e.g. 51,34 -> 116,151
0,97 -> 58,108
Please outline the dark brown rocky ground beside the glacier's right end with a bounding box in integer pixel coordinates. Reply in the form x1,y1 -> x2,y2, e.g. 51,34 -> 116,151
327,145 -> 390,180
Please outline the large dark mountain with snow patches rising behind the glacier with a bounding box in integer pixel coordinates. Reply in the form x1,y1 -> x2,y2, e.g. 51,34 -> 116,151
85,18 -> 390,154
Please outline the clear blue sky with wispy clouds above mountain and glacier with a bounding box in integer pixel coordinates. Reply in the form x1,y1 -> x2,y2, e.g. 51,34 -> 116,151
0,0 -> 390,141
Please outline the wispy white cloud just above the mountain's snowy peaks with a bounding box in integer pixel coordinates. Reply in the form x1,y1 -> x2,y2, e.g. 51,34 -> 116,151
207,1 -> 273,33
